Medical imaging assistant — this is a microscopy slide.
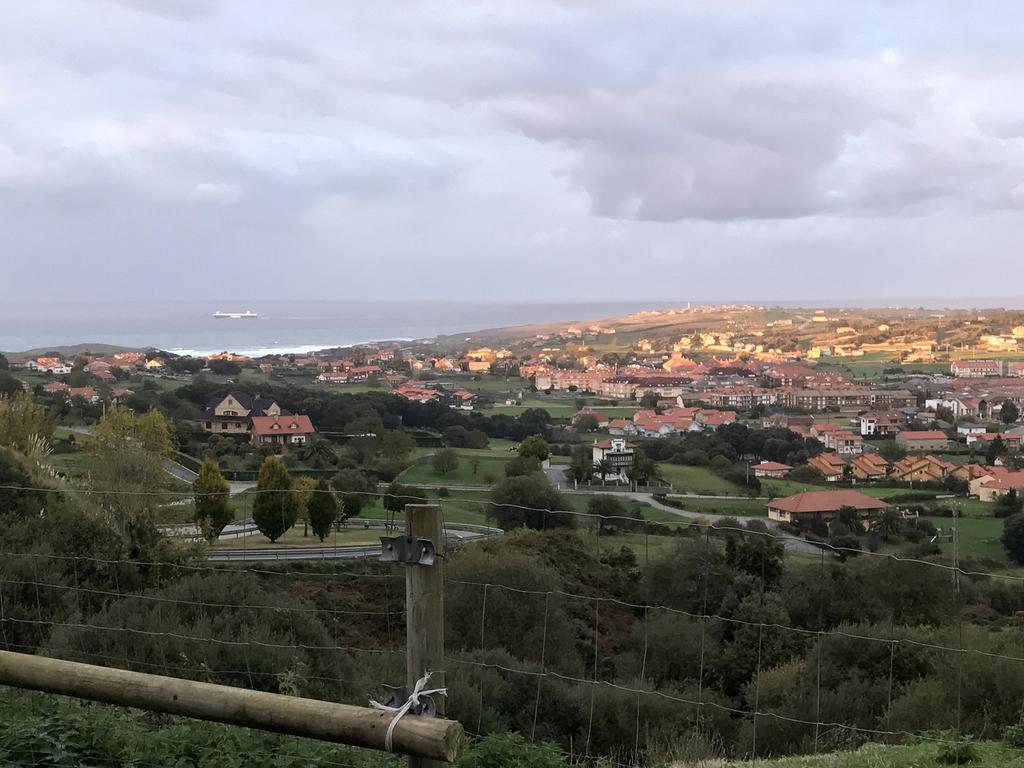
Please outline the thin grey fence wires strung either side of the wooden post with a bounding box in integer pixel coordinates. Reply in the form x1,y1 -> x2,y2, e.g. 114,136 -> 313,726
0,479 -> 1007,768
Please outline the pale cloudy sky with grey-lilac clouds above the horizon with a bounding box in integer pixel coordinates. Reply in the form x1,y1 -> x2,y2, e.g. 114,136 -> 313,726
0,0 -> 1024,300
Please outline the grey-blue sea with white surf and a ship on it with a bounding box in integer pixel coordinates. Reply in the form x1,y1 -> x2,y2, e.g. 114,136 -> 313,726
0,301 -> 671,356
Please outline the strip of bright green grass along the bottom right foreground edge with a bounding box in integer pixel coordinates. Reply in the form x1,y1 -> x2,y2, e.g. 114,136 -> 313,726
724,741 -> 1024,768
